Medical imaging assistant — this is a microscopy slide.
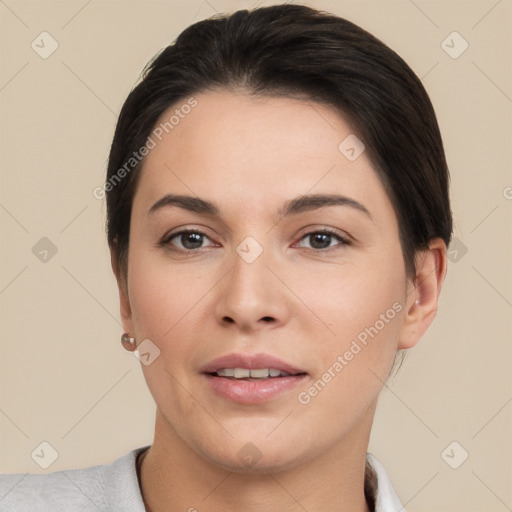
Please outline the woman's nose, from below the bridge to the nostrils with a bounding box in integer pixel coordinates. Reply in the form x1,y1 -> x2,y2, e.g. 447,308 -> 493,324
215,243 -> 290,333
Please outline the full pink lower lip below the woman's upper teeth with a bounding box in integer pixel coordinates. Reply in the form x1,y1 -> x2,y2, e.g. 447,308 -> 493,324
203,374 -> 306,404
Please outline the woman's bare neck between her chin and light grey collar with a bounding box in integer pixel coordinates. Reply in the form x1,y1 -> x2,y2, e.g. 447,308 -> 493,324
141,408 -> 374,512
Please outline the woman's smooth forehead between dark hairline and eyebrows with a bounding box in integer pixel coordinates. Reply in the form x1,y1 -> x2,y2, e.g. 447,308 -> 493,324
135,90 -> 391,226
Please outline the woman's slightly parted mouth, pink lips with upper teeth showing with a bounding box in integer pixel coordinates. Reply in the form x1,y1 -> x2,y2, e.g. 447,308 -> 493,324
201,354 -> 308,405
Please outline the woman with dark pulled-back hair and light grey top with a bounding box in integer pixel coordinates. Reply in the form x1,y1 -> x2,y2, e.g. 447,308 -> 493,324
0,5 -> 452,512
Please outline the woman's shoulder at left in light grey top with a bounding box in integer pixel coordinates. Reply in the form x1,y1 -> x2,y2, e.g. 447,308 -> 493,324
0,446 -> 147,512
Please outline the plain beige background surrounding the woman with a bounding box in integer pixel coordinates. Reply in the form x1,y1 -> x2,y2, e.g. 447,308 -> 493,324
0,0 -> 512,512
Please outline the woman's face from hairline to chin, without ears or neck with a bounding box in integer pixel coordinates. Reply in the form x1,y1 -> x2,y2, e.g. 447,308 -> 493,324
122,90 -> 414,470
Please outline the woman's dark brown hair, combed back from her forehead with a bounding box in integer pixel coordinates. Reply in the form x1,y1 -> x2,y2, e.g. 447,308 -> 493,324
105,4 -> 452,277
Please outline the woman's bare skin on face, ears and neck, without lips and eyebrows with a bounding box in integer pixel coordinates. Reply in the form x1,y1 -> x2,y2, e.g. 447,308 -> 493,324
112,90 -> 446,512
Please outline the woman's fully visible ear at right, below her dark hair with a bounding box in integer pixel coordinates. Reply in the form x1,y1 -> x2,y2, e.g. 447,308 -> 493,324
398,238 -> 446,350
